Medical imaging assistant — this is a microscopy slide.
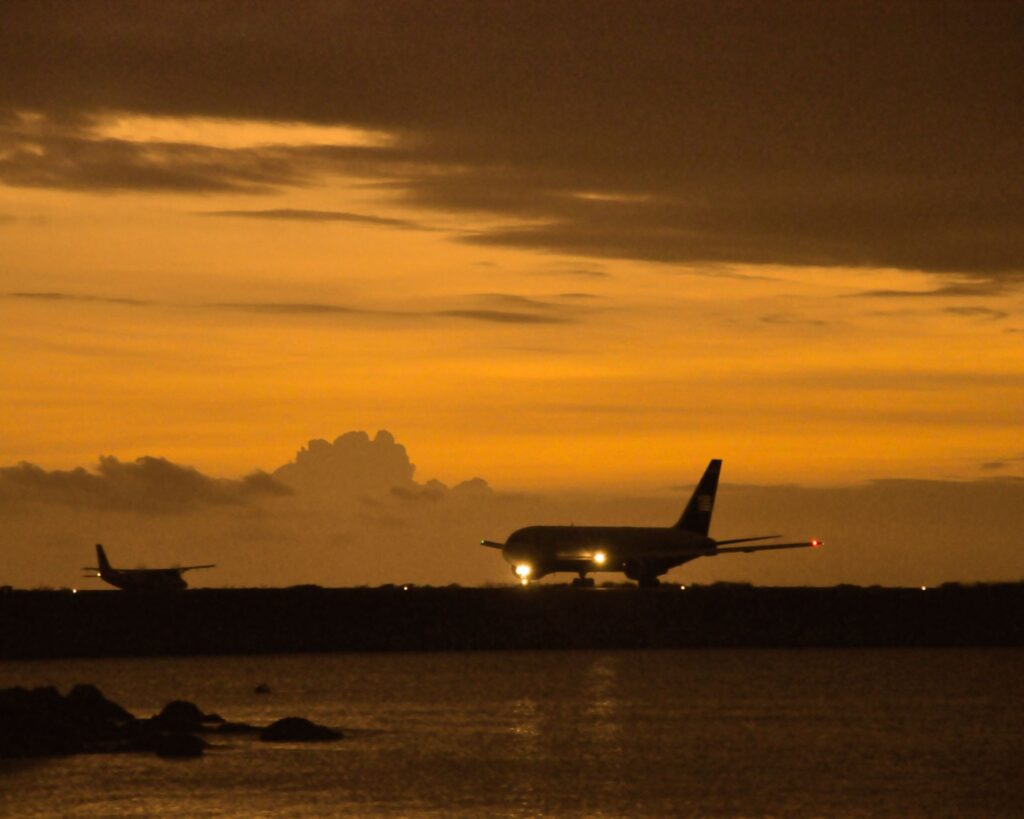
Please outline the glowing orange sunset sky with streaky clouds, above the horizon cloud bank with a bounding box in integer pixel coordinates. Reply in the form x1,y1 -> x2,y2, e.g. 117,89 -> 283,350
0,0 -> 1024,583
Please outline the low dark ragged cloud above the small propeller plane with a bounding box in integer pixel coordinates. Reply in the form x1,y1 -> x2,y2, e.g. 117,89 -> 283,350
0,456 -> 290,513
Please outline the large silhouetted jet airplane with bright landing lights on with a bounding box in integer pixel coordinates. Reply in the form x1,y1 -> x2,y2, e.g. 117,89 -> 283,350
480,459 -> 822,587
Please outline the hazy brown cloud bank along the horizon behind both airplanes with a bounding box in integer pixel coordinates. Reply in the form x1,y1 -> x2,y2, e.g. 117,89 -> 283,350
0,430 -> 1024,586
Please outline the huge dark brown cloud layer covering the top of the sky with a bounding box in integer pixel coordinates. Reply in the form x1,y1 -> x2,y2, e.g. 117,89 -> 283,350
0,0 -> 1024,278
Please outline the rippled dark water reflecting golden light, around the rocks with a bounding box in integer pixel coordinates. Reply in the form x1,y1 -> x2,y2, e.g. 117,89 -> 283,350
0,649 -> 1024,817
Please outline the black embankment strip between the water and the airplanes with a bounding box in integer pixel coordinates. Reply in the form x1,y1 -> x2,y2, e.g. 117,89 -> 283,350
0,584 -> 1024,658
